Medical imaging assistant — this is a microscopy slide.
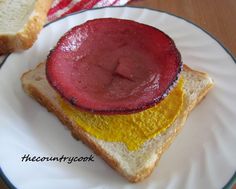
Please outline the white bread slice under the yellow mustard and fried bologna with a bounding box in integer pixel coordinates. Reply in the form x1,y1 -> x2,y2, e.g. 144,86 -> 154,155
21,63 -> 213,182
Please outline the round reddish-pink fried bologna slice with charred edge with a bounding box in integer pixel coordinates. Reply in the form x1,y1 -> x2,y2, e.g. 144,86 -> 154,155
46,18 -> 182,114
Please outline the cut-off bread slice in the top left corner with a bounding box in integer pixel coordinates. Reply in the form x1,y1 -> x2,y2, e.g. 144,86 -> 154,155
0,0 -> 52,55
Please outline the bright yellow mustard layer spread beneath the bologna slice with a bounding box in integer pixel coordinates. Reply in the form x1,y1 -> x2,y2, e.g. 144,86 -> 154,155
60,79 -> 184,151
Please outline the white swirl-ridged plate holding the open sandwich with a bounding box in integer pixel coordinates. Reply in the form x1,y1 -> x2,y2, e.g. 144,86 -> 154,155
0,7 -> 236,189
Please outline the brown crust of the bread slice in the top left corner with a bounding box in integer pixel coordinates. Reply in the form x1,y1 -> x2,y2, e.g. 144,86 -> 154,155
0,0 -> 53,55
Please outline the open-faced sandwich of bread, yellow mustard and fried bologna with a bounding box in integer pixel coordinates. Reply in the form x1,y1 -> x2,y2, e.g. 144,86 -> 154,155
21,18 -> 213,182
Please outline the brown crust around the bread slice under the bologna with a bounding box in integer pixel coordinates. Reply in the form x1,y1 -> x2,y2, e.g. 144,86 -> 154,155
21,63 -> 213,183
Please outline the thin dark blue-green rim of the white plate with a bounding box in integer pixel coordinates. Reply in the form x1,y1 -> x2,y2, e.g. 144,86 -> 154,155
0,5 -> 236,189
